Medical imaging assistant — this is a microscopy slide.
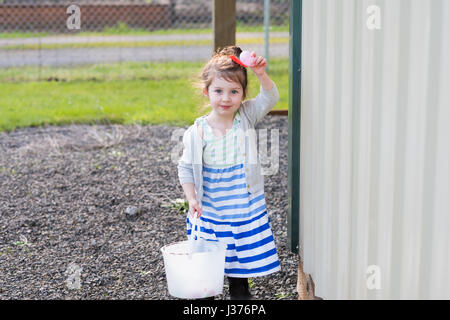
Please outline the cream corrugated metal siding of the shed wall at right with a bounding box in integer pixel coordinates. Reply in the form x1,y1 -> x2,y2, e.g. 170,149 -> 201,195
300,0 -> 450,299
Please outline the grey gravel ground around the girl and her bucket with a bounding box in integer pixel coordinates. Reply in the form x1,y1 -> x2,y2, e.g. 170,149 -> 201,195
0,116 -> 298,299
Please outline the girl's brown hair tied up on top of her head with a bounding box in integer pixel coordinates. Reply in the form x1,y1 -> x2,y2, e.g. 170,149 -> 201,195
201,46 -> 248,99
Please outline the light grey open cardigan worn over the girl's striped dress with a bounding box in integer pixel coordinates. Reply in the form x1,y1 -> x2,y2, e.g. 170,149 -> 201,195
178,84 -> 279,205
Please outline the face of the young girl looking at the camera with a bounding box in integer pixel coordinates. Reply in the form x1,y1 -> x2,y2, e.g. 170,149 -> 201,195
203,78 -> 244,116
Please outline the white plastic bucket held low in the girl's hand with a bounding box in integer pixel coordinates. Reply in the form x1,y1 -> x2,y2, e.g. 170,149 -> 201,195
161,219 -> 226,299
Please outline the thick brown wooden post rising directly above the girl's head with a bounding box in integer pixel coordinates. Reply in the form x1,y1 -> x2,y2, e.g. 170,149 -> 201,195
213,0 -> 236,51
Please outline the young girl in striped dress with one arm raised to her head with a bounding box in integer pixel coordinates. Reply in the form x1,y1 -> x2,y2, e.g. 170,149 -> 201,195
178,47 -> 280,299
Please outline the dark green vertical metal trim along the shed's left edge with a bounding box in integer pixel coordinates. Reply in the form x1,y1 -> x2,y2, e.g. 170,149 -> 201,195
287,0 -> 303,253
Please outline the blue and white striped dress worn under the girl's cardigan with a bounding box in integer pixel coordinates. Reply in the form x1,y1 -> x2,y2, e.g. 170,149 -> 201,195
187,112 -> 280,278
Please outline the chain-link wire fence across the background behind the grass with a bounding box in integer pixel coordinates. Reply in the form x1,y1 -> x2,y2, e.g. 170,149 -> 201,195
0,0 -> 289,81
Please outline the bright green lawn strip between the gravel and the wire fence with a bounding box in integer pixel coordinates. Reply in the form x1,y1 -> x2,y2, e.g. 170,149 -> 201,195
0,59 -> 288,131
